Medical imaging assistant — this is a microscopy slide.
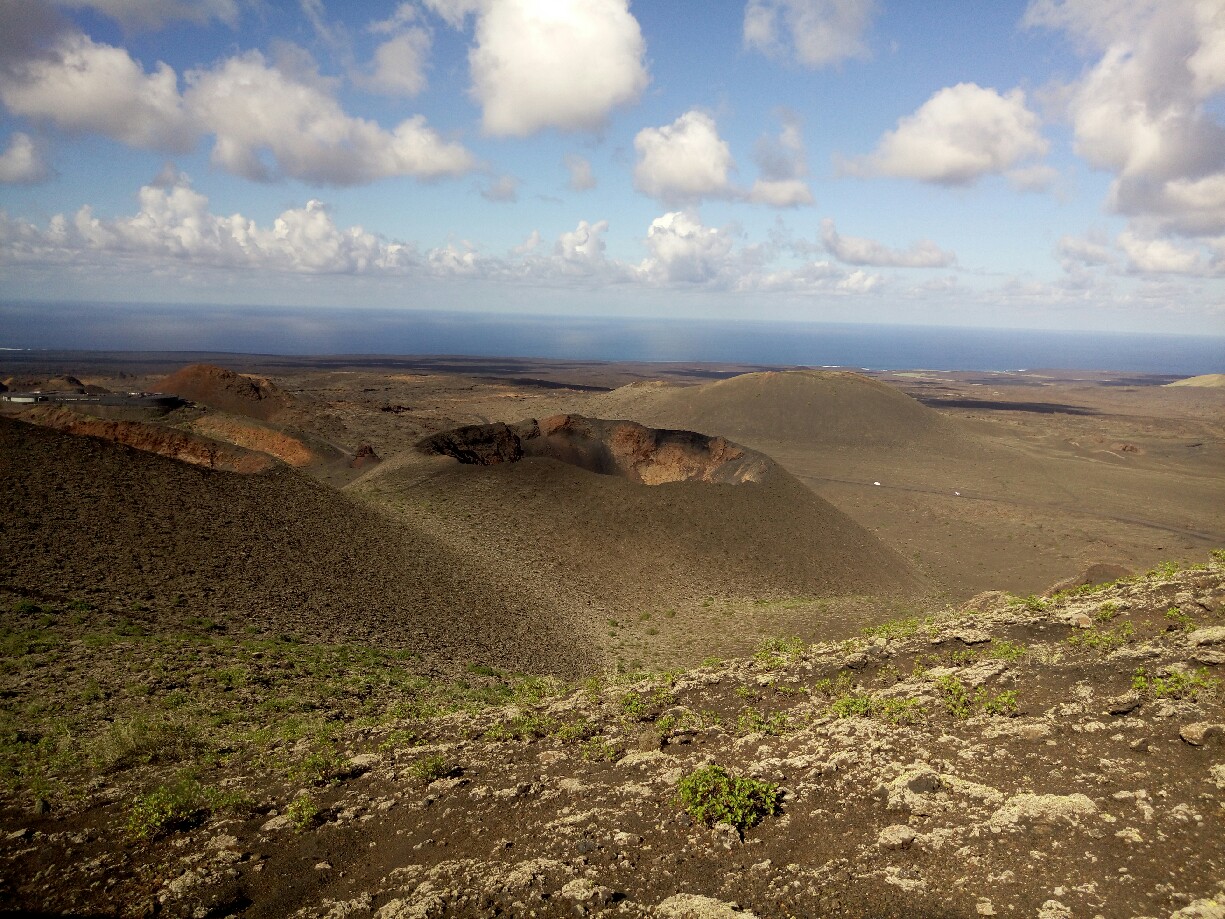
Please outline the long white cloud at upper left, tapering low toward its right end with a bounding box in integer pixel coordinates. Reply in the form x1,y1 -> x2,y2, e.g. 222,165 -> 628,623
186,51 -> 475,185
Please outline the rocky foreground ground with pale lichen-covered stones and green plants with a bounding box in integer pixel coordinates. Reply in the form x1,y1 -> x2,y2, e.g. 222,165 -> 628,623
0,551 -> 1225,919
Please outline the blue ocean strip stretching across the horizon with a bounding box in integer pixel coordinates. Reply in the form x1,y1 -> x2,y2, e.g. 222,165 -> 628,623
0,304 -> 1225,376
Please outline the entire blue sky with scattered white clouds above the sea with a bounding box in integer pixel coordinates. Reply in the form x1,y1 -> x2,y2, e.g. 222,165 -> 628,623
0,0 -> 1225,335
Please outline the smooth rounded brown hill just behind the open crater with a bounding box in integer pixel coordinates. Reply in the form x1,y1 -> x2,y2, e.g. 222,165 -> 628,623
590,370 -> 949,447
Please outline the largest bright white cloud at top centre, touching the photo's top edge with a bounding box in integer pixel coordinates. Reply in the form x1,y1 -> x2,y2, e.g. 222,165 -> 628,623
465,0 -> 649,137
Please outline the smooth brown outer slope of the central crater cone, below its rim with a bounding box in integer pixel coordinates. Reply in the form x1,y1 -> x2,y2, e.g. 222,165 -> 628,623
359,419 -> 916,614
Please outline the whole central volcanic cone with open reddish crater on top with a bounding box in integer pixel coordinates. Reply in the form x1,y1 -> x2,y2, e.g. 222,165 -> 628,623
356,415 -> 916,613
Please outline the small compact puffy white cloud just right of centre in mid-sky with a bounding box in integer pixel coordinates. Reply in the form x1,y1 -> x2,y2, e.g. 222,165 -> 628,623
633,112 -> 735,202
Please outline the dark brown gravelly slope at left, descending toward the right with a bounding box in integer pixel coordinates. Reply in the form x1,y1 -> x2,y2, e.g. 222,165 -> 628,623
0,418 -> 590,671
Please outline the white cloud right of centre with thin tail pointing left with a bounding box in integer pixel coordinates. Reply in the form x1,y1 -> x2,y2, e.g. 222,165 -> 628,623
846,83 -> 1049,185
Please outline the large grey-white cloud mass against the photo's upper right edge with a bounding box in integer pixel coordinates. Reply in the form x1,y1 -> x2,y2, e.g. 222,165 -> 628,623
1024,0 -> 1225,248
